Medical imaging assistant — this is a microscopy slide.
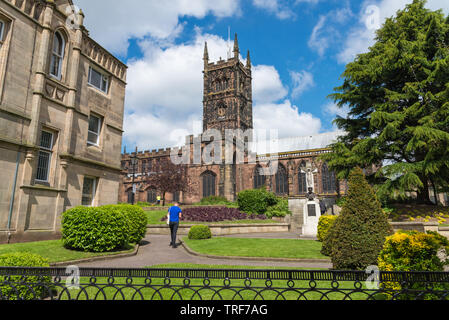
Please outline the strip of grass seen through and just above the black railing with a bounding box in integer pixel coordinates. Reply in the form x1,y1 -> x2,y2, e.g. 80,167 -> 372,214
46,263 -> 383,301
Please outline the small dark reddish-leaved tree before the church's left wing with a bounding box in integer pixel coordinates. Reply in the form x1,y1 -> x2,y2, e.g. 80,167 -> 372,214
147,157 -> 189,205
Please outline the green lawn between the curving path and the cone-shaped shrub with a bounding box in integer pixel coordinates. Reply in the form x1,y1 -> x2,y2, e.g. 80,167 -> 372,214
183,237 -> 328,259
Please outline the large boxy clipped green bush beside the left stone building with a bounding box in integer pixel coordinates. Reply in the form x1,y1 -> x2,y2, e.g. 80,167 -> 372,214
61,205 -> 131,252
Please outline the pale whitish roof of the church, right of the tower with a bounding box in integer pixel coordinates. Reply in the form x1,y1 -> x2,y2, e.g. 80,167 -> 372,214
252,131 -> 345,155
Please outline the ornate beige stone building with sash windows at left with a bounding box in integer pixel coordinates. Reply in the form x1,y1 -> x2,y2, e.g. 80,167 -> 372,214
0,0 -> 127,242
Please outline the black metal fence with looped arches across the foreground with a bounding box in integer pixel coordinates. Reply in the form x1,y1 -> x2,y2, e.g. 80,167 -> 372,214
0,267 -> 449,300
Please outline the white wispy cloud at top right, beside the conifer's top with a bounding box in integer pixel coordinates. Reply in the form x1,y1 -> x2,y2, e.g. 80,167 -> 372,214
337,0 -> 449,64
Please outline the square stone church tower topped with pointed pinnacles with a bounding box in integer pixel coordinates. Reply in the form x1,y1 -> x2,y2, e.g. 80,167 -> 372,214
203,34 -> 253,136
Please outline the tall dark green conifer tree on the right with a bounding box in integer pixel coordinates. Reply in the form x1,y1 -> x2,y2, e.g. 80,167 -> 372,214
323,0 -> 449,203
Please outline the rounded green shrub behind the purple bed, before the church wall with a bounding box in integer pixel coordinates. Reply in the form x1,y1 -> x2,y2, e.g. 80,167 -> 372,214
237,189 -> 278,214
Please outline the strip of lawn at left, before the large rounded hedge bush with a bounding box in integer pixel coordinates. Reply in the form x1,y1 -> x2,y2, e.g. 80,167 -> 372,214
0,240 -> 134,263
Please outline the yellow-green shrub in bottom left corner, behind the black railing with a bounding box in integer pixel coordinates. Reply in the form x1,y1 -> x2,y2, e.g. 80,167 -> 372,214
0,252 -> 52,300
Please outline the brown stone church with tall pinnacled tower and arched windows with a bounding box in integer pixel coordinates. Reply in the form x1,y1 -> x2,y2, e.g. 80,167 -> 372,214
119,35 -> 346,204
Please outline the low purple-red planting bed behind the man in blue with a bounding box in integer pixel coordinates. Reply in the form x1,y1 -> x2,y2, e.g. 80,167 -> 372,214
161,207 -> 267,222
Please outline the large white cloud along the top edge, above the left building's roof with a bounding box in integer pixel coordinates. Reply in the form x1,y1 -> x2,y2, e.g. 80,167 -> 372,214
74,0 -> 240,54
